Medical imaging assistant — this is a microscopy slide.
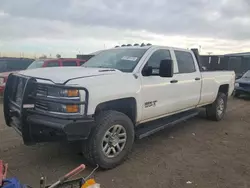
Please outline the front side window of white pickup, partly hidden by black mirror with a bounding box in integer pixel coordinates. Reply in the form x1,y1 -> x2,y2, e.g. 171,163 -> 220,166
144,49 -> 171,75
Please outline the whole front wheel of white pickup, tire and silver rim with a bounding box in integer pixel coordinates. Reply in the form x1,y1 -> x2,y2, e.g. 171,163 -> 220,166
83,111 -> 134,169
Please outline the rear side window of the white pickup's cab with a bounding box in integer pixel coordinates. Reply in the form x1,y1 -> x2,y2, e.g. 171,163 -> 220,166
174,51 -> 195,73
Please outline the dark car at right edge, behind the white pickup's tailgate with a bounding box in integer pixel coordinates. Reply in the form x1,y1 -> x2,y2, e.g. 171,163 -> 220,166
234,70 -> 250,97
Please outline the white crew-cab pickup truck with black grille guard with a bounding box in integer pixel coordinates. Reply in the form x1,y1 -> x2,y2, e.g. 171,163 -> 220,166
4,46 -> 235,169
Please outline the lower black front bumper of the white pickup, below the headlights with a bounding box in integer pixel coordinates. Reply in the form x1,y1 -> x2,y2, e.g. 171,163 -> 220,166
10,115 -> 94,145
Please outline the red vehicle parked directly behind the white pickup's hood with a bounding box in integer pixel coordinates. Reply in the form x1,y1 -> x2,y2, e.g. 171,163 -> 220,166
0,58 -> 86,94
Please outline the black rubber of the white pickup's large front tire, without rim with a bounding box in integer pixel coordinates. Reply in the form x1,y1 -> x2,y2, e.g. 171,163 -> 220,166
82,111 -> 135,169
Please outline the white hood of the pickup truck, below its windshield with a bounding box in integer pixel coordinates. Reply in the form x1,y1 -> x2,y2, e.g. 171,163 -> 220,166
19,67 -> 122,84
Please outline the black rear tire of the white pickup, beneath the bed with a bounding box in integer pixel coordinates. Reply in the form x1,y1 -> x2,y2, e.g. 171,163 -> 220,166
206,92 -> 227,121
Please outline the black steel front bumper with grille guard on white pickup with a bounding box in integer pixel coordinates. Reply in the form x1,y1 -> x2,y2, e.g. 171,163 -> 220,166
4,75 -> 95,145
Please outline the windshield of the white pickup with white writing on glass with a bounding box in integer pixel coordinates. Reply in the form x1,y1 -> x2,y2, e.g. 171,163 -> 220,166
82,48 -> 147,72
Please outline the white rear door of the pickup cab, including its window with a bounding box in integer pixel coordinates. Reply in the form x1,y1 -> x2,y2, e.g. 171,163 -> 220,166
174,50 -> 201,110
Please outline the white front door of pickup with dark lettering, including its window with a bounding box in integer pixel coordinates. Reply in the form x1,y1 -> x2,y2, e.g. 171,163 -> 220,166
141,49 -> 179,121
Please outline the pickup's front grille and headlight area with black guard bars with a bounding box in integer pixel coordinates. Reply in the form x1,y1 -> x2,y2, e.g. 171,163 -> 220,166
4,74 -> 89,120
